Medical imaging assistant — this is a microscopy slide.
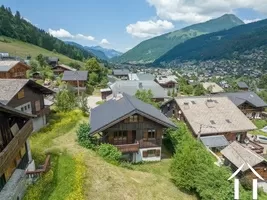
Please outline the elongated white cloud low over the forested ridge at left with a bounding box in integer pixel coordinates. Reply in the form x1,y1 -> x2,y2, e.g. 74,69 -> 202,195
48,28 -> 95,41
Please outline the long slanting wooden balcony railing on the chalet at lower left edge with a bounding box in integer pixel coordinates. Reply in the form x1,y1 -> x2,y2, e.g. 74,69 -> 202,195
0,120 -> 33,174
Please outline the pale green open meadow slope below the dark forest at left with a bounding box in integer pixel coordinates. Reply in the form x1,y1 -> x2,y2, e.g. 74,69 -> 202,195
0,36 -> 84,65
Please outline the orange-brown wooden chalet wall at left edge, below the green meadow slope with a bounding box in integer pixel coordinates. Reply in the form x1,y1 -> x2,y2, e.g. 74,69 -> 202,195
0,62 -> 30,79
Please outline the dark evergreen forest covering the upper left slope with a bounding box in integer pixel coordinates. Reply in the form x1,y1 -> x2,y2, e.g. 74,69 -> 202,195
0,5 -> 92,61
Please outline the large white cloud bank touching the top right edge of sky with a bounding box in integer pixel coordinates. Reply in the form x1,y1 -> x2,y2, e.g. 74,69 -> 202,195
146,0 -> 267,23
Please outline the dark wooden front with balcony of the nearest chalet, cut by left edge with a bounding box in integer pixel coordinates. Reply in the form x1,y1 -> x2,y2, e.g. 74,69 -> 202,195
0,111 -> 33,190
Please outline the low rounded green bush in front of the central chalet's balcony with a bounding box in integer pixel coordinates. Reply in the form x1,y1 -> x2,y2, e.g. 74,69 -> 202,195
97,144 -> 122,164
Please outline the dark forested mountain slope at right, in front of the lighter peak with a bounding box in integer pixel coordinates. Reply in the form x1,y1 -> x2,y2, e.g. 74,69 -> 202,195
154,20 -> 267,64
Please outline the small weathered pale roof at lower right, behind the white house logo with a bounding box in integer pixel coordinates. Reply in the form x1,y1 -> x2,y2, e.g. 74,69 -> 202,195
221,141 -> 265,172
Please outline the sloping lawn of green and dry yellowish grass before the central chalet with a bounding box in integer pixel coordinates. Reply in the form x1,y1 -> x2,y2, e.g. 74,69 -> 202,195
25,109 -> 197,200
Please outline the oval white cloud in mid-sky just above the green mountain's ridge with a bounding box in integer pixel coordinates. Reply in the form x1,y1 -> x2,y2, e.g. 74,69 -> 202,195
126,20 -> 174,38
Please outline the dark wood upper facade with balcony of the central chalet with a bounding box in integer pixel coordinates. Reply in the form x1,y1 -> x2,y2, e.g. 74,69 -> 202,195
102,114 -> 164,152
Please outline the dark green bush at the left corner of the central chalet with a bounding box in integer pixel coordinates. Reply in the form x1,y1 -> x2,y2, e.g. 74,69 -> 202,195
76,123 -> 97,149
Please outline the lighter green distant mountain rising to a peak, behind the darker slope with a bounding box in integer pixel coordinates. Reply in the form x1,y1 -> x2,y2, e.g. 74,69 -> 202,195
113,14 -> 244,63
